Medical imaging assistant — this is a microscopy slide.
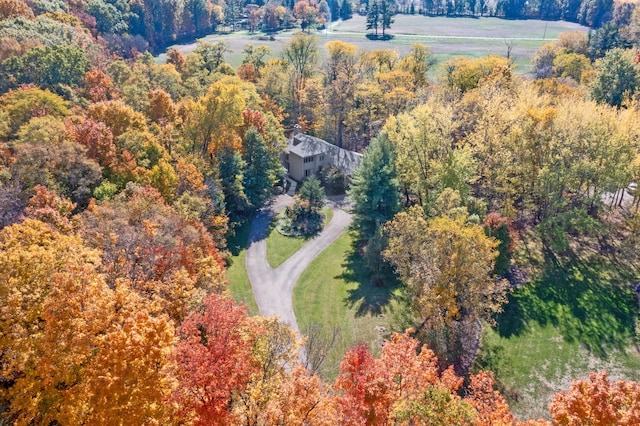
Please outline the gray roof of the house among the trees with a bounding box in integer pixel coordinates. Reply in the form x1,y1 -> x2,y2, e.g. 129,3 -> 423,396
289,133 -> 362,176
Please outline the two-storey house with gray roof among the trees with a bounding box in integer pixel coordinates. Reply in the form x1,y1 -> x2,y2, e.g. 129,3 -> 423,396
283,128 -> 362,182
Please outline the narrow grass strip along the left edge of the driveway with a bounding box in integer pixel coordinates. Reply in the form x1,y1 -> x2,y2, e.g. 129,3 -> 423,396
227,220 -> 259,315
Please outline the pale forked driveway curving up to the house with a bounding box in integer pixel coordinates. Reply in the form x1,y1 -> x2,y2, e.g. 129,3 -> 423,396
247,195 -> 351,331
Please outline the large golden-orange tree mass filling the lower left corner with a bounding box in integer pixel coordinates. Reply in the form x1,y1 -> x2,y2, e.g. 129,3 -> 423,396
0,218 -> 174,425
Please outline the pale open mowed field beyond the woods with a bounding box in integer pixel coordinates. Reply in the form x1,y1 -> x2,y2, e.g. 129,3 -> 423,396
157,15 -> 588,74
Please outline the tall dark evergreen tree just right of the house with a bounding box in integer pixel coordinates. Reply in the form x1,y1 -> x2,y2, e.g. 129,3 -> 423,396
348,133 -> 401,240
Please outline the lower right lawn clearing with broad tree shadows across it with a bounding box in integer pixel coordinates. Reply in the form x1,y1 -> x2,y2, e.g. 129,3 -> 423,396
478,243 -> 640,419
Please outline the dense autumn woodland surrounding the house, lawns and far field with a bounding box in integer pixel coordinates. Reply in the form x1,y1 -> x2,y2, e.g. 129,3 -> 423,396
0,0 -> 640,425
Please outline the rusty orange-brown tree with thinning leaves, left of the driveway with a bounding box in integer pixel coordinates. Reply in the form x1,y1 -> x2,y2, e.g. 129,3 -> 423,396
80,184 -> 226,322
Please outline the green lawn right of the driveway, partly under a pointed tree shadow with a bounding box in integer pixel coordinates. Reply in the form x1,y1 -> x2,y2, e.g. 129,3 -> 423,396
293,233 -> 402,379
